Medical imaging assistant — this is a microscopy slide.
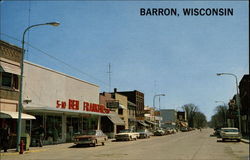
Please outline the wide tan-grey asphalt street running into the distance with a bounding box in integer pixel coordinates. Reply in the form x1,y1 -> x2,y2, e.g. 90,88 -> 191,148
1,129 -> 249,160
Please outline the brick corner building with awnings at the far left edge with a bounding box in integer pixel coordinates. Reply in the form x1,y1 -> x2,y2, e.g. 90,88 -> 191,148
0,40 -> 35,148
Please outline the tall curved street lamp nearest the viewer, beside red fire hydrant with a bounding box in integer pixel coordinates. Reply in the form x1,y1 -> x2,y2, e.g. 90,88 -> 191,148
17,22 -> 60,151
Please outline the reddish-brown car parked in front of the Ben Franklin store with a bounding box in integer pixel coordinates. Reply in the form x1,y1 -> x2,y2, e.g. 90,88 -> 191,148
74,130 -> 108,147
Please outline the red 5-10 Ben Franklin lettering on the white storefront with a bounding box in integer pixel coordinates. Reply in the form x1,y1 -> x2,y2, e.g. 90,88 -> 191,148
56,99 -> 110,114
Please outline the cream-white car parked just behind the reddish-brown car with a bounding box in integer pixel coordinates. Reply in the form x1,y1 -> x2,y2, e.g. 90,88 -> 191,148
115,129 -> 140,141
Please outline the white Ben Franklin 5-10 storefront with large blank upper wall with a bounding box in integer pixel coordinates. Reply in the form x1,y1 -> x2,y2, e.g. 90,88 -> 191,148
23,62 -> 110,144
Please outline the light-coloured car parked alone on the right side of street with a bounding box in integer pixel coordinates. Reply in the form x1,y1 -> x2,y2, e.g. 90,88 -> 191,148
220,128 -> 241,142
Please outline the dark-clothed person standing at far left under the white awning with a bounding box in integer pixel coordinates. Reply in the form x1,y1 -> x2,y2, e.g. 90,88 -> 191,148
1,123 -> 10,152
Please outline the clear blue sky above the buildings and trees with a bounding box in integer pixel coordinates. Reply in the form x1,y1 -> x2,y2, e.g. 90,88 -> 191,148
0,0 -> 249,120
